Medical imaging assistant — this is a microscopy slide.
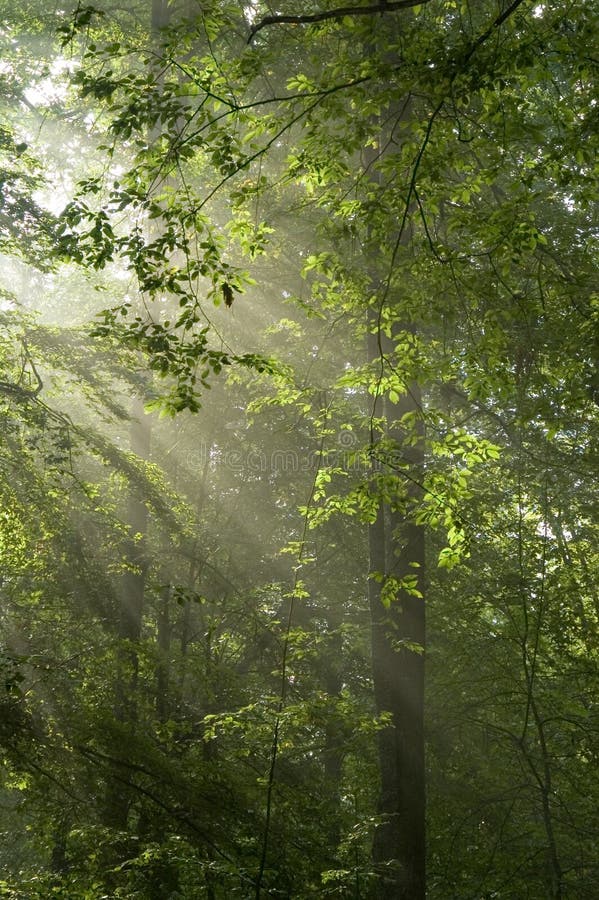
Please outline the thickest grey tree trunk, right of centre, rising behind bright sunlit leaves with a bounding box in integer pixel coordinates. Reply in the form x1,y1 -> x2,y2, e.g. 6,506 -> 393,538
364,26 -> 426,872
